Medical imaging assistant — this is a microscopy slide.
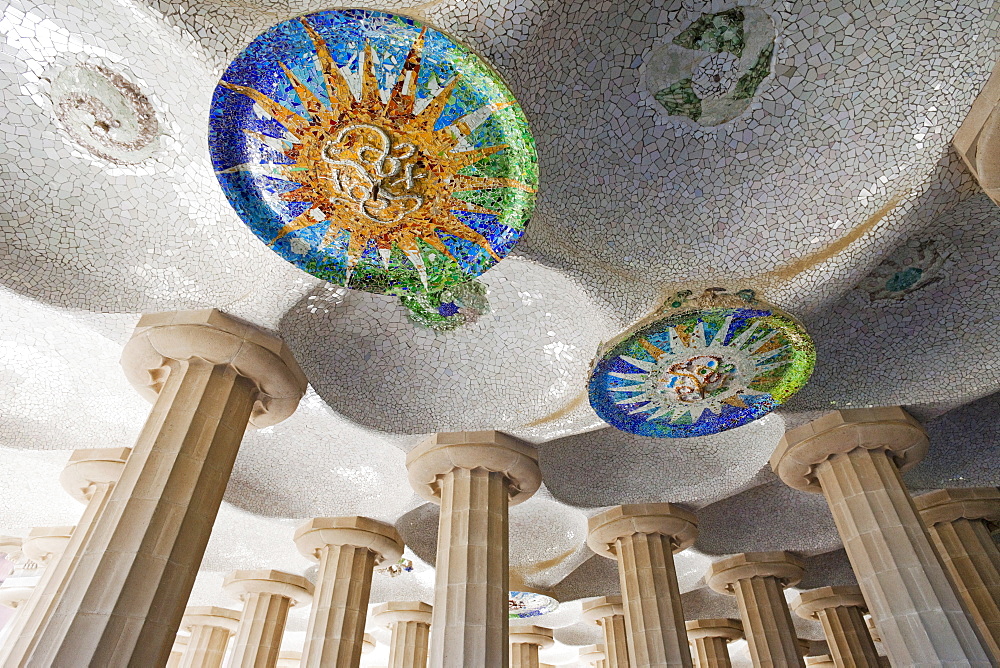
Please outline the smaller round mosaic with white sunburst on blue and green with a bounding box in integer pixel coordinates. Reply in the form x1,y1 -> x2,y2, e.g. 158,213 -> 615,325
589,290 -> 816,438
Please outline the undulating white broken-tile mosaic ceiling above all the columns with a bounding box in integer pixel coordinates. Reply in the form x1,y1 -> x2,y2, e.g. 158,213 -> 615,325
0,0 -> 1000,666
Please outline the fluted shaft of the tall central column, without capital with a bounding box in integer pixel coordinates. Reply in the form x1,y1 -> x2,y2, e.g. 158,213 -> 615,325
430,469 -> 510,668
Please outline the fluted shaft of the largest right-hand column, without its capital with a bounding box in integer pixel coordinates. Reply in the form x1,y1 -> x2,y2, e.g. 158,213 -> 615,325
816,448 -> 990,666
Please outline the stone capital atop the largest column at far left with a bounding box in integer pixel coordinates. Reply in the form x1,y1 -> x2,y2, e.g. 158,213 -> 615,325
122,309 -> 308,427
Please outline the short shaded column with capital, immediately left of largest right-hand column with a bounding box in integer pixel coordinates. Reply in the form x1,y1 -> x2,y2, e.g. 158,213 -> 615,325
792,586 -> 879,668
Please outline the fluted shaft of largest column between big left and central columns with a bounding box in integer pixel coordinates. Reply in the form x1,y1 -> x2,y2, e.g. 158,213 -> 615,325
302,545 -> 378,668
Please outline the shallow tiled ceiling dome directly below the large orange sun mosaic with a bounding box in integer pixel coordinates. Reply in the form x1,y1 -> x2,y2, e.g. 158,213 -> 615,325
280,258 -> 613,433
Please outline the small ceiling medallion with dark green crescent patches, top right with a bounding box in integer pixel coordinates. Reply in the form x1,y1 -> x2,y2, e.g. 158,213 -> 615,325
645,6 -> 775,126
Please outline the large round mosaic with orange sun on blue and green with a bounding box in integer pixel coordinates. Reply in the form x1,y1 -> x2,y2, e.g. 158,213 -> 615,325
209,9 -> 538,295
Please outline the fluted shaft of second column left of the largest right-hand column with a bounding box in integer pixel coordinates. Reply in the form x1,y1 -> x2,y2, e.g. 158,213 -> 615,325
733,577 -> 803,668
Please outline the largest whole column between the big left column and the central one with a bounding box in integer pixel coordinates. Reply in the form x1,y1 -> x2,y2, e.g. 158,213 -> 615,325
295,517 -> 403,668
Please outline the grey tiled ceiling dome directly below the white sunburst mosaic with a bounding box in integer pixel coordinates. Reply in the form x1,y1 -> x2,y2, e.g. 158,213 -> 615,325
538,415 -> 784,508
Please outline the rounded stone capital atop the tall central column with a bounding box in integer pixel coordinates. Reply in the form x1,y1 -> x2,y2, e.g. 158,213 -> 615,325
406,431 -> 542,505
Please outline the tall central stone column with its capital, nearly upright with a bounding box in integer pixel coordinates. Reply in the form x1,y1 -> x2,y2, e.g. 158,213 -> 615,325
406,431 -> 542,668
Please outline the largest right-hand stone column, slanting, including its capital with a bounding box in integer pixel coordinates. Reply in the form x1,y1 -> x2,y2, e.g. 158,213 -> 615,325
771,407 -> 991,666
